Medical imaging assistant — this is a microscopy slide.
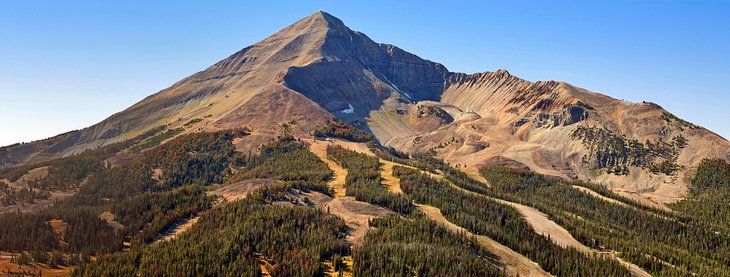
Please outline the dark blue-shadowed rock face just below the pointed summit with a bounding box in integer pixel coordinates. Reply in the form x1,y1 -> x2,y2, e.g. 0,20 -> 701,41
284,14 -> 450,121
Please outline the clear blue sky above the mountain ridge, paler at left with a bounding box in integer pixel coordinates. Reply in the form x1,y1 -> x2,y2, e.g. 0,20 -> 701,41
0,0 -> 730,145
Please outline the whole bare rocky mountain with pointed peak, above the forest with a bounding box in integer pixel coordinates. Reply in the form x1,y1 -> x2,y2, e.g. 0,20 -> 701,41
0,12 -> 730,202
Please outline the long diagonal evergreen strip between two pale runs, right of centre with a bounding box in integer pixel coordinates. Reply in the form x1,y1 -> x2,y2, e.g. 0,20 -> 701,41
393,167 -> 630,276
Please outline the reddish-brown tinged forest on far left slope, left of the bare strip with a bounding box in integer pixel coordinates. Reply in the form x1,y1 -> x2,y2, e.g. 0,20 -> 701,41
0,130 -> 247,274
